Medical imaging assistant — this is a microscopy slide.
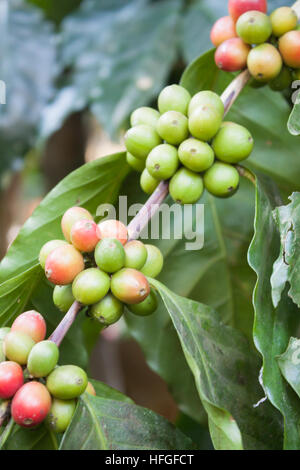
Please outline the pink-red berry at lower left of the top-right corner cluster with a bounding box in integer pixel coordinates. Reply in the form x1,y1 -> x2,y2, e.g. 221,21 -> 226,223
215,38 -> 251,72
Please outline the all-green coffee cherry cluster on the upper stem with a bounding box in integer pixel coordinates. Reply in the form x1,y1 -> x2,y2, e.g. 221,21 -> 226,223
125,85 -> 253,204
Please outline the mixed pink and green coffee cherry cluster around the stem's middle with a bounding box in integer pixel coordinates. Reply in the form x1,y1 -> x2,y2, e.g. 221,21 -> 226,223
39,207 -> 163,326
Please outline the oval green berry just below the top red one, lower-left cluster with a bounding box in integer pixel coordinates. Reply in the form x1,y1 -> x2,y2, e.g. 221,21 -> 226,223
27,341 -> 59,378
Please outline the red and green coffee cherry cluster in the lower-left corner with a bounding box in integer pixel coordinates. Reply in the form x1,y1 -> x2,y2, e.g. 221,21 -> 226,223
0,310 -> 96,433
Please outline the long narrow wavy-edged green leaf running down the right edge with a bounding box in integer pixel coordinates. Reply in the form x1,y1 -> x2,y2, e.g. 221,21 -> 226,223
249,175 -> 300,450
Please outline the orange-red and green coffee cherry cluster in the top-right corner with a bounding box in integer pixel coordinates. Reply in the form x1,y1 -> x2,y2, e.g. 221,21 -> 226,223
211,0 -> 300,91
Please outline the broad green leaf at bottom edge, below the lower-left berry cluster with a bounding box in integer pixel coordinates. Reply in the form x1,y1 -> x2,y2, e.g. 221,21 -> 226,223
60,393 -> 193,450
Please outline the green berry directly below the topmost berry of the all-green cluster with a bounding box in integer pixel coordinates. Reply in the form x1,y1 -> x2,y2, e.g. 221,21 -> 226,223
156,111 -> 189,145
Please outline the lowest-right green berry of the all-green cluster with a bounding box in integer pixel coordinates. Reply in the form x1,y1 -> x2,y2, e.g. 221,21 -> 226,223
204,162 -> 240,198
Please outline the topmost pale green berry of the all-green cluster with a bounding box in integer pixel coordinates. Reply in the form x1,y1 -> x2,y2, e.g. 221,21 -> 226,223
158,85 -> 191,115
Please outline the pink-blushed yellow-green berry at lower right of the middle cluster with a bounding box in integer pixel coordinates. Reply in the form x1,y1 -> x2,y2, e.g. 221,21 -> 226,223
111,268 -> 150,305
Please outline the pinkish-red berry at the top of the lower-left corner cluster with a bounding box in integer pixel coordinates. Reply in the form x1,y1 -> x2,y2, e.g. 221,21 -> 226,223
11,310 -> 47,343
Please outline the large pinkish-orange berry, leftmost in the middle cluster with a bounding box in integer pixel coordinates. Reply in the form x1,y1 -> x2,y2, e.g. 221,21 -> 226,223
45,245 -> 84,285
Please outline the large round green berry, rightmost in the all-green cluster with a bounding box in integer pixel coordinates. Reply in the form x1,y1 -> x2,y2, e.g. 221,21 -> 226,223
212,124 -> 253,163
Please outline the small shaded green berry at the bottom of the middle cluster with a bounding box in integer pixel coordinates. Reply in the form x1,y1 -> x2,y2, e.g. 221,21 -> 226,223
91,294 -> 124,326
